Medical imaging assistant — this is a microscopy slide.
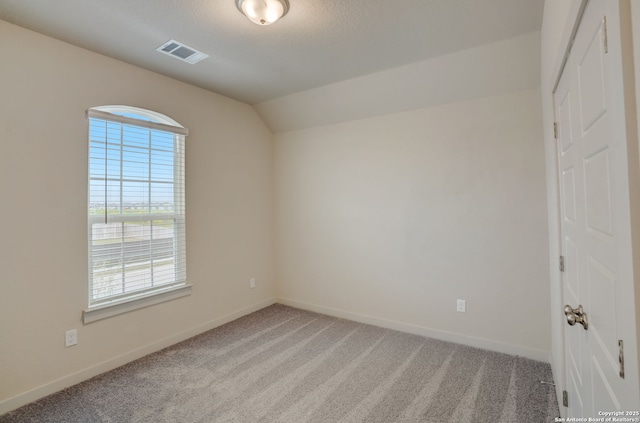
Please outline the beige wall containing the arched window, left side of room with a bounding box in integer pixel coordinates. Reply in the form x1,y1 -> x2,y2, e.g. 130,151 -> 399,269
0,21 -> 275,414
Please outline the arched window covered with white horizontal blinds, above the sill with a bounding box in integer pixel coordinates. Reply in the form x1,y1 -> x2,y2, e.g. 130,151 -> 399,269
87,106 -> 188,309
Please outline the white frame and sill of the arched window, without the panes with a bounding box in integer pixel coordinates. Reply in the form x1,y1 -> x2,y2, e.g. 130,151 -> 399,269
83,106 -> 192,324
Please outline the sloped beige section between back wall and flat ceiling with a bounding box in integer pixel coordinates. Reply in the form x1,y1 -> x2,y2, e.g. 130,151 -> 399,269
255,31 -> 540,133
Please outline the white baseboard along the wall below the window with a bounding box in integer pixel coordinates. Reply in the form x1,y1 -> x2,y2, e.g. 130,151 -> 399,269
0,298 -> 276,415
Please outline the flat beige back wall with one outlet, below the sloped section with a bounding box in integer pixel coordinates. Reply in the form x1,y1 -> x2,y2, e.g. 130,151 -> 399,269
275,89 -> 550,360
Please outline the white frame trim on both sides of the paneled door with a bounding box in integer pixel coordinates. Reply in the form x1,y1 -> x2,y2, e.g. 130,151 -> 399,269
543,0 -> 640,417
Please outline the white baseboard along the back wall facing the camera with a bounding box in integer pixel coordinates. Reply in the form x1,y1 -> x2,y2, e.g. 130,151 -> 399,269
277,298 -> 550,363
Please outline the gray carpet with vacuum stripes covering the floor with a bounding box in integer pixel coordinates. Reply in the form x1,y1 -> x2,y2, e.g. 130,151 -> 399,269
0,304 -> 559,423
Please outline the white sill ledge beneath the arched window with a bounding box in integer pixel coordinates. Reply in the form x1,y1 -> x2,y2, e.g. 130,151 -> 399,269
82,285 -> 193,325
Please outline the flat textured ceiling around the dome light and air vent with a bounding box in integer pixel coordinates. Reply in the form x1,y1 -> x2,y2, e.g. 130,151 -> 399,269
0,0 -> 544,104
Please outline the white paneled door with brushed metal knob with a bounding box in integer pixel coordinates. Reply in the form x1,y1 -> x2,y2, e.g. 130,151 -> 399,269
554,0 -> 640,417
